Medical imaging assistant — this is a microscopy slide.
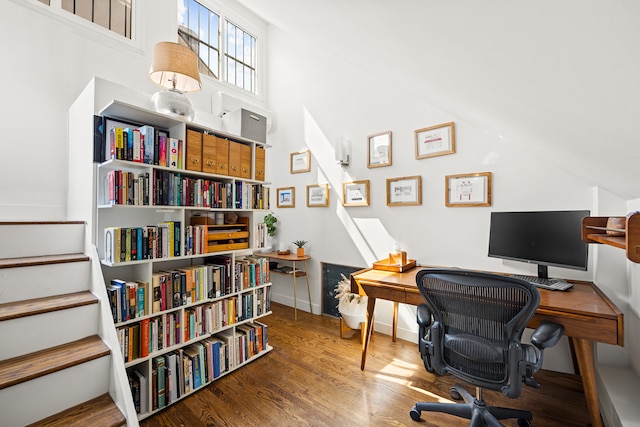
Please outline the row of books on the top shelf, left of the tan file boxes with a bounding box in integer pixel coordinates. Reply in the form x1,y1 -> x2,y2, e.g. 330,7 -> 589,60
105,125 -> 184,169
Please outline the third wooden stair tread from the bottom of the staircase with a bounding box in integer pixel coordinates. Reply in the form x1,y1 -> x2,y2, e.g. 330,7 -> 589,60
0,291 -> 98,322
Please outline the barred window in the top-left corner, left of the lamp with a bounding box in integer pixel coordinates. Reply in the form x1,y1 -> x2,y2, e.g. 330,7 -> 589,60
38,0 -> 133,39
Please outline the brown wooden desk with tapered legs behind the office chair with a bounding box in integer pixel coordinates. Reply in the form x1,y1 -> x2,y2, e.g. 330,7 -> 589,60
351,267 -> 624,427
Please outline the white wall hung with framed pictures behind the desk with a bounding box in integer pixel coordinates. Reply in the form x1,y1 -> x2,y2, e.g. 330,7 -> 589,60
267,28 -> 627,372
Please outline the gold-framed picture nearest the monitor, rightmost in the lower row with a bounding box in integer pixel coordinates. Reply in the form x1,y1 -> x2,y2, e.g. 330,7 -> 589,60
445,172 -> 491,206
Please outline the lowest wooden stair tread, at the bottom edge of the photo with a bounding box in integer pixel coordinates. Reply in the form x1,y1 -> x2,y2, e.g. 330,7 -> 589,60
27,394 -> 126,427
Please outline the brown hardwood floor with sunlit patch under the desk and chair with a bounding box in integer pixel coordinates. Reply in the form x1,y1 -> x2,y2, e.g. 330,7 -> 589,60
140,303 -> 589,427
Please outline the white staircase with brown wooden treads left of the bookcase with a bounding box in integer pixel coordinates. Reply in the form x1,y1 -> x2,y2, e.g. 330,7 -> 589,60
0,222 -> 129,427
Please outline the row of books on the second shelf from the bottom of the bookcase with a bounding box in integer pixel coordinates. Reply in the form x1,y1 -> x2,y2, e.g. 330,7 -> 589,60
116,288 -> 271,362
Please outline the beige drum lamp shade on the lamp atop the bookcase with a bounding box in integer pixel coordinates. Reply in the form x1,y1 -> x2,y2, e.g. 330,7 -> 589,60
149,42 -> 202,92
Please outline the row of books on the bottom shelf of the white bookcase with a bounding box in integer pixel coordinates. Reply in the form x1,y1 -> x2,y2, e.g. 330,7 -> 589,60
128,322 -> 268,414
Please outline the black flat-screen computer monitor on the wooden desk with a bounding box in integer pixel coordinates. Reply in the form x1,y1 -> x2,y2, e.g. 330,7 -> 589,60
489,210 -> 590,279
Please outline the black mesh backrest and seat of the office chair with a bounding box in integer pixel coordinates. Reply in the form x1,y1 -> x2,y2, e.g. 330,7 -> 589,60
417,270 -> 540,397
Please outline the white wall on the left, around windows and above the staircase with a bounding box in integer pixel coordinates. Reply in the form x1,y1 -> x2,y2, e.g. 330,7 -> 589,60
0,0 -> 266,220
